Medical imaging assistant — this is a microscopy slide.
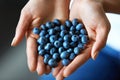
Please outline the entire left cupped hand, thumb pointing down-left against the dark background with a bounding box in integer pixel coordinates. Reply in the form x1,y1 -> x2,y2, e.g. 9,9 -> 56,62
11,0 -> 69,75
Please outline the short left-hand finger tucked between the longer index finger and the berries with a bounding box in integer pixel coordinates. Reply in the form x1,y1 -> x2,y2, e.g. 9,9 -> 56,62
37,56 -> 46,75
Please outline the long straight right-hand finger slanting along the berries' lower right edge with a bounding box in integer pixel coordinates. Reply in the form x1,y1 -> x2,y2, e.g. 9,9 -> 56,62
63,47 -> 91,77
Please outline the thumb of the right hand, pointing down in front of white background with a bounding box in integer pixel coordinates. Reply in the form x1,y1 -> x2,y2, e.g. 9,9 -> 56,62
91,22 -> 110,59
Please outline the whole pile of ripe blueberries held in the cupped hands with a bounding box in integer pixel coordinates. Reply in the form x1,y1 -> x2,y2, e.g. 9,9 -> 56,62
33,19 -> 88,67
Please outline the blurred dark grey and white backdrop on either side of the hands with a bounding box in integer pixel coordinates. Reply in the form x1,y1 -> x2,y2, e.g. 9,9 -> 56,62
0,0 -> 120,80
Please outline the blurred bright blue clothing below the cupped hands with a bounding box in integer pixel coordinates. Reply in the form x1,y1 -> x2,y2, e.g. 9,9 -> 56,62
39,46 -> 120,80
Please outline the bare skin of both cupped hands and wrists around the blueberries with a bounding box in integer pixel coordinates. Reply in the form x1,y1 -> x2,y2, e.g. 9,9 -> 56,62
11,0 -> 120,80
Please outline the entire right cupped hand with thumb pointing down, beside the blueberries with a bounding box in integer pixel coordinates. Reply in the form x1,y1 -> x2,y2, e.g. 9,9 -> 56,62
53,0 -> 110,80
